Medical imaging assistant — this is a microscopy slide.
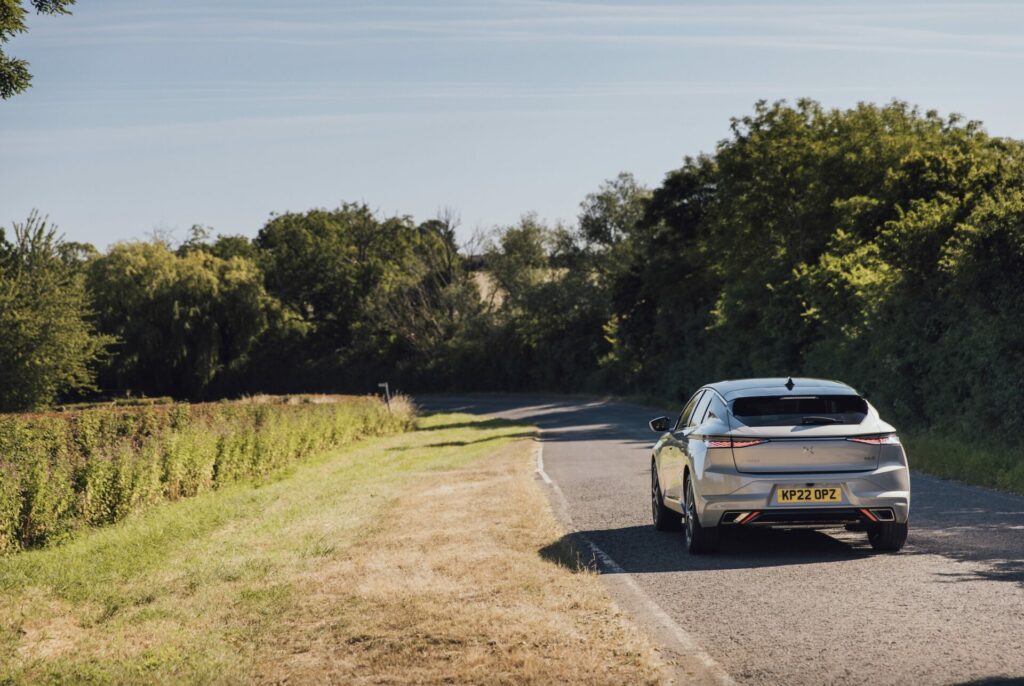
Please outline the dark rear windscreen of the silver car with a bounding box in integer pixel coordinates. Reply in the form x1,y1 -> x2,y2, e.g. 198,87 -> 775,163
732,395 -> 867,426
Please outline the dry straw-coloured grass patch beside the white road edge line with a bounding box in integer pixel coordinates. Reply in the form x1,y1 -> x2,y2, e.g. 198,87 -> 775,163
261,441 -> 662,684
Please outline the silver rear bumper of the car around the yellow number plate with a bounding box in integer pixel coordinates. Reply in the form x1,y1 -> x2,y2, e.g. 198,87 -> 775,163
695,465 -> 910,528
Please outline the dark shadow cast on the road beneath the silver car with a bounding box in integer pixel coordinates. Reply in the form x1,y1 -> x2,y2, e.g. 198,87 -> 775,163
538,525 -> 872,574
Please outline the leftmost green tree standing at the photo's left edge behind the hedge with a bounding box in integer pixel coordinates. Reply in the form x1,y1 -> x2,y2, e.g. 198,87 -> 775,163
0,212 -> 113,411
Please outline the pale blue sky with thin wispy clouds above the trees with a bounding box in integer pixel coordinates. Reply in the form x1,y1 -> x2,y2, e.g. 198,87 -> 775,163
0,0 -> 1024,247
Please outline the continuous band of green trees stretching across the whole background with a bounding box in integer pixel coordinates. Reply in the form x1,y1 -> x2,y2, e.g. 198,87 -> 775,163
0,100 -> 1024,495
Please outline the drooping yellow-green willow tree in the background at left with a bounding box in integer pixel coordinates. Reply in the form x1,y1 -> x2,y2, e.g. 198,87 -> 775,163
89,242 -> 276,398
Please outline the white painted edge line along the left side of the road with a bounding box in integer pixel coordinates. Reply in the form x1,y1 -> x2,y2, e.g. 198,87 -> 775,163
534,438 -> 736,686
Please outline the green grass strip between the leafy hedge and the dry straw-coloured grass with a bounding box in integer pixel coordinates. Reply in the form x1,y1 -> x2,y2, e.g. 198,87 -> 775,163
0,416 -> 531,683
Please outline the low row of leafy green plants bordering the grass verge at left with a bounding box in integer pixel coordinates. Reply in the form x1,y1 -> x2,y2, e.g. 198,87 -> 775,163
0,396 -> 414,552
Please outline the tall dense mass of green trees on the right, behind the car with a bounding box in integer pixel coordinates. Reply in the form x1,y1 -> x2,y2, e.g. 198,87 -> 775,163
591,100 -> 1024,434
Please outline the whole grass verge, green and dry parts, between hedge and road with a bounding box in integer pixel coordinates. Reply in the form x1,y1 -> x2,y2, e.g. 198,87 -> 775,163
0,413 -> 664,684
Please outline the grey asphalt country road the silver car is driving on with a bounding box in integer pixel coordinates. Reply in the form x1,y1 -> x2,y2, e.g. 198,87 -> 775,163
419,395 -> 1024,684
